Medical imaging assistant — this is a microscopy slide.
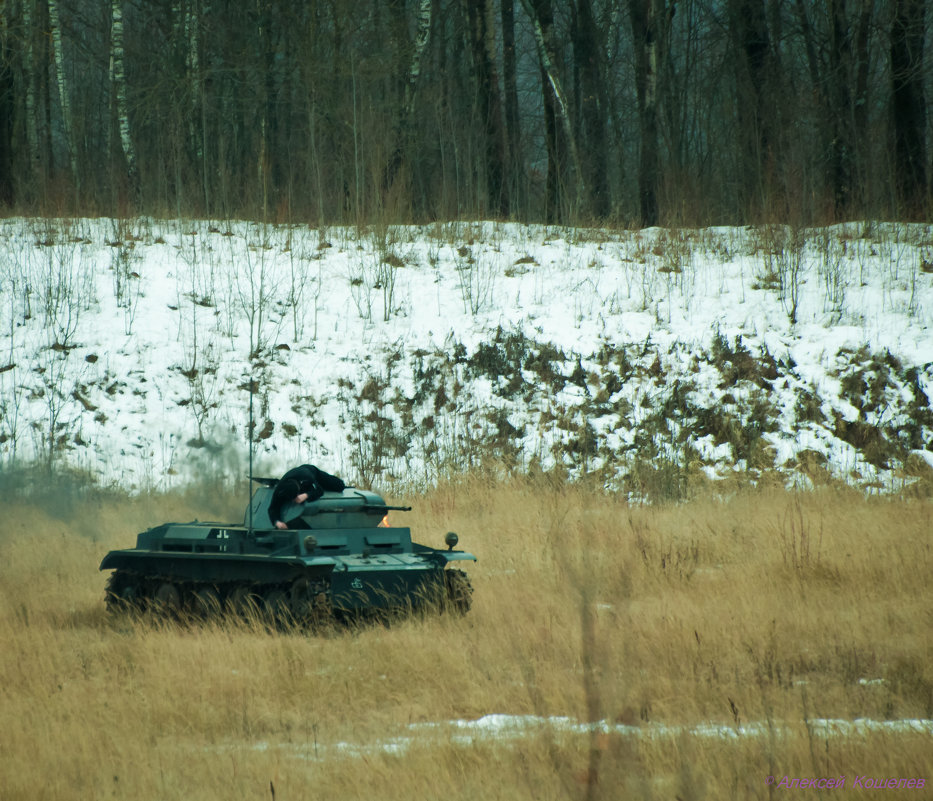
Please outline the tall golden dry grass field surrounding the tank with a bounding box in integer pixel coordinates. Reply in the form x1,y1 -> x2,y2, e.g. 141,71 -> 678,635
0,479 -> 933,801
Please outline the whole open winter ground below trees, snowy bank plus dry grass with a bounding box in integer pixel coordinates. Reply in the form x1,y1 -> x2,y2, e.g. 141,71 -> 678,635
0,219 -> 933,801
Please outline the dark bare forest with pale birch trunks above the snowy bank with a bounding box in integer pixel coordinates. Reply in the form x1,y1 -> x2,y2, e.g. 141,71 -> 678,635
0,0 -> 933,224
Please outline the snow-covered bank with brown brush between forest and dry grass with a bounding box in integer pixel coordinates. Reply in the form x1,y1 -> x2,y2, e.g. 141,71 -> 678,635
0,218 -> 933,494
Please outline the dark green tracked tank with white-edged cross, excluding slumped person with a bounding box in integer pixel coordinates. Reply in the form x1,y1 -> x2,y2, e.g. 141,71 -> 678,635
100,479 -> 476,626
